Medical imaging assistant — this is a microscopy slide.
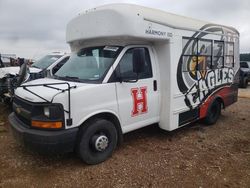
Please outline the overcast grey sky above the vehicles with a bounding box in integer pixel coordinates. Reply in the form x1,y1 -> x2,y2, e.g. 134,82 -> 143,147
0,0 -> 250,59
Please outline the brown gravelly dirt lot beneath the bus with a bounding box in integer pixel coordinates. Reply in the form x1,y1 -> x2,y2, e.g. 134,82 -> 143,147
0,89 -> 250,187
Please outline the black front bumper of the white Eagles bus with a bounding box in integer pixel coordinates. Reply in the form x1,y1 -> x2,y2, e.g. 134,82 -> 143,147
9,113 -> 78,154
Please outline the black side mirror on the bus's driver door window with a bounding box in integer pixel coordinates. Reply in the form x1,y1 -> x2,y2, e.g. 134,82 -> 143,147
133,48 -> 146,74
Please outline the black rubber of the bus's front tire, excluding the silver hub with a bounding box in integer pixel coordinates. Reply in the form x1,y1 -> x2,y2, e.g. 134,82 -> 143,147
78,119 -> 118,164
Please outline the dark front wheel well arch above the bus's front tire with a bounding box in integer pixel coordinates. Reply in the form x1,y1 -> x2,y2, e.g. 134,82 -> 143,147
81,112 -> 123,145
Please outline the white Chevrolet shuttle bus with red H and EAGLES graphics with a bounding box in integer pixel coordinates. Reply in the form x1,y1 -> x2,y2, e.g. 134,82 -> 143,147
9,4 -> 239,164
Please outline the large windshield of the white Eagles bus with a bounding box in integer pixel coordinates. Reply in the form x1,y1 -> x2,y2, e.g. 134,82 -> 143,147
55,46 -> 121,82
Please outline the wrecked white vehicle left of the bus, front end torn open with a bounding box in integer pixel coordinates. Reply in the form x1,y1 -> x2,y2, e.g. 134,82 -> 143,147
0,52 -> 69,102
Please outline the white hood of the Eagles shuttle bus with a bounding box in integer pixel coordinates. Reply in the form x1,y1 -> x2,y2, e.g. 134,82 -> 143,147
15,78 -> 89,102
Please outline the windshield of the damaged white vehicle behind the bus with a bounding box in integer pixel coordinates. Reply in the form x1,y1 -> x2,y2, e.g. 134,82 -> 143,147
32,55 -> 62,69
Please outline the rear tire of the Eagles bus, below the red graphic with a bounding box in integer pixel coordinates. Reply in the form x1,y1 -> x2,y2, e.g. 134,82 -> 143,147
204,100 -> 221,125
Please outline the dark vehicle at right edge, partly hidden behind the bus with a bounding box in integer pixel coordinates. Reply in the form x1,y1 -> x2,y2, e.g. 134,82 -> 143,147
240,61 -> 250,88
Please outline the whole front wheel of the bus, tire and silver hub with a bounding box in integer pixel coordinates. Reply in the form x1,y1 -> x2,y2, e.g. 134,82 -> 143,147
78,119 -> 118,164
